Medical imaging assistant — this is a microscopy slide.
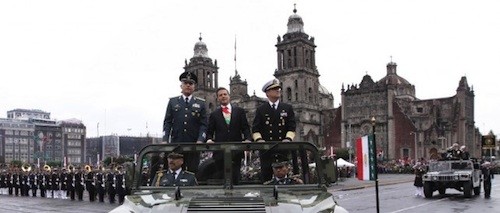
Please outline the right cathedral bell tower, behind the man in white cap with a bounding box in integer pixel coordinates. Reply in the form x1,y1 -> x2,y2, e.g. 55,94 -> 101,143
274,8 -> 323,145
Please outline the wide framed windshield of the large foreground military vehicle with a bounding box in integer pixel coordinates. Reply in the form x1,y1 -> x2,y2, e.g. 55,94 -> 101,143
133,142 -> 324,190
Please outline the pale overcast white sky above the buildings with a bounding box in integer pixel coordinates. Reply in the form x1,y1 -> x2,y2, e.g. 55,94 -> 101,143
0,0 -> 500,136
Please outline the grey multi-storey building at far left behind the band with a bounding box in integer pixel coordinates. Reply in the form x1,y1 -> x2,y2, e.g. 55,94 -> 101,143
0,109 -> 86,166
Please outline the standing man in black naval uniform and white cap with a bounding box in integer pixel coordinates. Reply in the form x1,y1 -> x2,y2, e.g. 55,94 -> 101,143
252,79 -> 296,180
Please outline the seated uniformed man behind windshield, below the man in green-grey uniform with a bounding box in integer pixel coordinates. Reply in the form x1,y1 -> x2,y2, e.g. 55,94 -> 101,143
153,152 -> 198,186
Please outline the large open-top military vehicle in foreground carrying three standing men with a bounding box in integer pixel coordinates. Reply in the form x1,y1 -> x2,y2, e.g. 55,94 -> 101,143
111,142 -> 347,213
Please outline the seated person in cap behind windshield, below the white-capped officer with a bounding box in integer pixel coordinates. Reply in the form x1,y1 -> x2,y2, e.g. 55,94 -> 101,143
264,154 -> 304,185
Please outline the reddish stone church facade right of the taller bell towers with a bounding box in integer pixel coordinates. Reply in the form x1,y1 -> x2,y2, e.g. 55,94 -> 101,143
338,61 -> 481,159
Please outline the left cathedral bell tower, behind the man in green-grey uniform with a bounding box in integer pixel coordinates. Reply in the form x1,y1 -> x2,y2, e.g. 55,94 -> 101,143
184,35 -> 219,113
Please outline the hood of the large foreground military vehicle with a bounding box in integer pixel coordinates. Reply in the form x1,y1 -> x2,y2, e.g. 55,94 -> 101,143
111,186 -> 347,213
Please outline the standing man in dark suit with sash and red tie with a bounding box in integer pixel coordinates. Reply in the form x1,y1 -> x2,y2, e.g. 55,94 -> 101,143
207,87 -> 251,183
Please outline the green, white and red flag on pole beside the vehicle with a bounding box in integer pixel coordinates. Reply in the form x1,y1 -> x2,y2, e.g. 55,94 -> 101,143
356,135 -> 376,180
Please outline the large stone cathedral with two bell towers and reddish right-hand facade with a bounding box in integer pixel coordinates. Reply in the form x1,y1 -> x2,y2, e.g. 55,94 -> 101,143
179,9 -> 481,160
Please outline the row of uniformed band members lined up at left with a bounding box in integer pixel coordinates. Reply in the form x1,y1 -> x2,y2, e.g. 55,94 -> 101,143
0,165 -> 128,204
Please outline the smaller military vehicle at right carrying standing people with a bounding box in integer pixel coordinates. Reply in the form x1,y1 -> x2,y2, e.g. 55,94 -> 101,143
422,159 -> 481,198
